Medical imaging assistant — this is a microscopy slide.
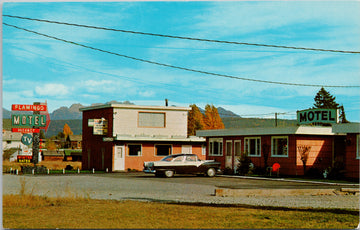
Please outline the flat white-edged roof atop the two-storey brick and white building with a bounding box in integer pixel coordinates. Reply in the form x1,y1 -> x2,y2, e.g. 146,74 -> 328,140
79,104 -> 191,111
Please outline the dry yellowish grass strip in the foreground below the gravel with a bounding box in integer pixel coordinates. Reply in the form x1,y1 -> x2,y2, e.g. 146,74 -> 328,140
3,194 -> 359,229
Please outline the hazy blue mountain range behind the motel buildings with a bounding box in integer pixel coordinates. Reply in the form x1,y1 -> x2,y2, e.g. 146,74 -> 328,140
3,101 -> 297,137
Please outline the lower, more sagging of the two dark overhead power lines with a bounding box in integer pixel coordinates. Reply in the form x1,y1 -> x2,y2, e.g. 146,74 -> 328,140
3,23 -> 360,88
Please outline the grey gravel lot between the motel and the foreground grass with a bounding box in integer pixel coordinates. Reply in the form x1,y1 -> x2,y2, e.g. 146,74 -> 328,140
2,173 -> 359,210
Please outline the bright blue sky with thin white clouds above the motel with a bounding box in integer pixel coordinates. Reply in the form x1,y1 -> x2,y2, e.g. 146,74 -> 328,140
2,1 -> 360,122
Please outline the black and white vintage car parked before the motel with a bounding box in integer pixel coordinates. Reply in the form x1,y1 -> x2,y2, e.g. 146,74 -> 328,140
143,154 -> 220,177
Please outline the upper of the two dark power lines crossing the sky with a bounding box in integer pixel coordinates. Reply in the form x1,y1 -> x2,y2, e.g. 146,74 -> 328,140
3,14 -> 360,54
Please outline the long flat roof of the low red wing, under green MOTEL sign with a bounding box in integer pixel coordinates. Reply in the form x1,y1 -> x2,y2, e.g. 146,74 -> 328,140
196,126 -> 335,137
